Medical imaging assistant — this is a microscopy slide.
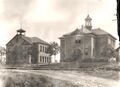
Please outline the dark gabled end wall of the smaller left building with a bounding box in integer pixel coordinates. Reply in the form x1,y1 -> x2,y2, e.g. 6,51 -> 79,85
6,35 -> 31,64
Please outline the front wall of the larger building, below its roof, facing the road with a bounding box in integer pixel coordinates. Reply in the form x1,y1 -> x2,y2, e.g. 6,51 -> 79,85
61,34 -> 95,62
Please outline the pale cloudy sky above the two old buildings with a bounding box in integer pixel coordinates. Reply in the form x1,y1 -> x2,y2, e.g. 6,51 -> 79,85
0,0 -> 118,46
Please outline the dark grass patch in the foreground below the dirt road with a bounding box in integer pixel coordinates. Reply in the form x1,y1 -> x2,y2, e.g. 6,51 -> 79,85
0,72 -> 82,87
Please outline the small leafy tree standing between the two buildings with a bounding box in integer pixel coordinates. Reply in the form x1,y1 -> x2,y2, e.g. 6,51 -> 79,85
46,42 -> 60,61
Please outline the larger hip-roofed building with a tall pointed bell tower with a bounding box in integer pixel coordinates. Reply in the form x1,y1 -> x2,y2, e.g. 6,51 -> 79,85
59,15 -> 116,62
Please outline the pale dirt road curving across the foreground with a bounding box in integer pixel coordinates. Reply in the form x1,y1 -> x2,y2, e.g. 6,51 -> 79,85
0,70 -> 120,87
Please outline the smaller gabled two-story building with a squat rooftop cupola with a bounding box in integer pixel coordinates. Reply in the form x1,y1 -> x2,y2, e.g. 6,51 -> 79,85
6,29 -> 51,64
